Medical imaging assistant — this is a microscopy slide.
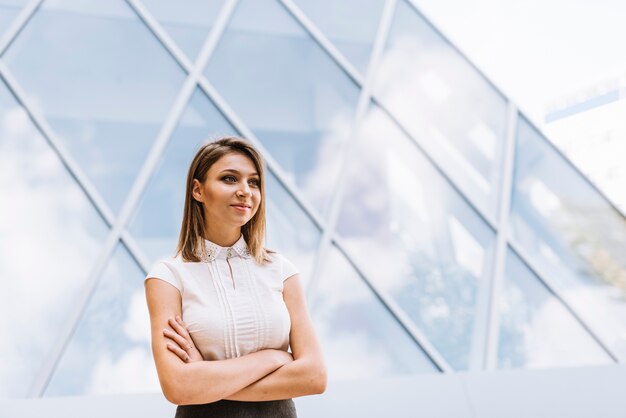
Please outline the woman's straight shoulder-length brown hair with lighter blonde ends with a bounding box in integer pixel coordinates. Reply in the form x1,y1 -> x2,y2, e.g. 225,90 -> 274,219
176,136 -> 270,264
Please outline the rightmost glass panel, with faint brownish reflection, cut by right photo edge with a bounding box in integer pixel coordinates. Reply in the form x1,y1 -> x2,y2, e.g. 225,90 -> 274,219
511,119 -> 626,360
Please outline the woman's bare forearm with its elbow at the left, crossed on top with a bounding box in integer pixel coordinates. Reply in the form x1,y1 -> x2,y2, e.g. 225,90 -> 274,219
162,350 -> 291,405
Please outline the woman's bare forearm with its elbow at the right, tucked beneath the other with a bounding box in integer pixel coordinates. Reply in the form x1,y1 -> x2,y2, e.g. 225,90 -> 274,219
226,359 -> 326,401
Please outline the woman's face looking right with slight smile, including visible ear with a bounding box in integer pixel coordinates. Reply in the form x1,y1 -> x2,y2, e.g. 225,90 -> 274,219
193,152 -> 261,229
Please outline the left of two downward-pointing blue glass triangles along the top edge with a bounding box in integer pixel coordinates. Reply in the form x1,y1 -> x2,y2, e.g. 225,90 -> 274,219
141,0 -> 224,61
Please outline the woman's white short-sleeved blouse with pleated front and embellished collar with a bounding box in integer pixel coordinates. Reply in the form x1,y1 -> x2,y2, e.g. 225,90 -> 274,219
146,235 -> 297,360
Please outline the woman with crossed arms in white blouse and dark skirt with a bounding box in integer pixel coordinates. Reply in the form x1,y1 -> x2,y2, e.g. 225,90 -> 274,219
145,137 -> 326,418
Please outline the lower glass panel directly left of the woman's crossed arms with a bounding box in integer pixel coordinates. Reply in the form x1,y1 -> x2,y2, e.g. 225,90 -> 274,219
44,244 -> 161,396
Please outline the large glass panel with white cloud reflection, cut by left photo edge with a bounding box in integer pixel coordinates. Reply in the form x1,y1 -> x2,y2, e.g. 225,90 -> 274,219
0,81 -> 108,398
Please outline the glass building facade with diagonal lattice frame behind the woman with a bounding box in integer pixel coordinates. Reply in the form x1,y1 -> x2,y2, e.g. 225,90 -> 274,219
0,0 -> 626,398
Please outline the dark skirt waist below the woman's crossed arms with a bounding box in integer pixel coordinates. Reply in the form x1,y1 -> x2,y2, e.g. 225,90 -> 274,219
175,399 -> 297,418
